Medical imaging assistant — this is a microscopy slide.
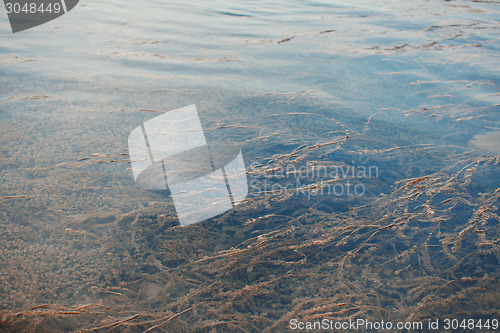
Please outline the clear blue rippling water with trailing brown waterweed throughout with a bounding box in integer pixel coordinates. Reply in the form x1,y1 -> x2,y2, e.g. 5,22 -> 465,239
0,1 -> 500,332
